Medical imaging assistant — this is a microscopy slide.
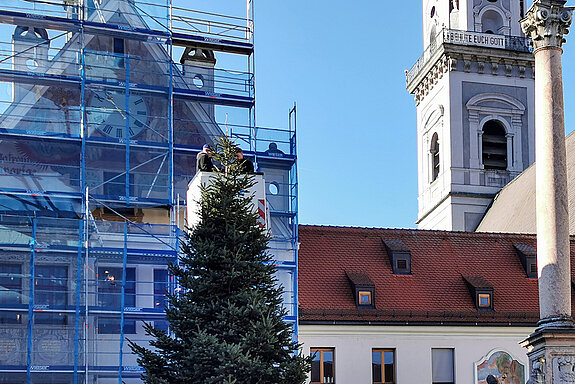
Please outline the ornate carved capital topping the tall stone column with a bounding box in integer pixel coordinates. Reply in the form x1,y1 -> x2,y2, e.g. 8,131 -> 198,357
521,0 -> 573,50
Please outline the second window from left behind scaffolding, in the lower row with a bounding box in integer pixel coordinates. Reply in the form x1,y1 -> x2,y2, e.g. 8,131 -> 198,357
34,265 -> 68,325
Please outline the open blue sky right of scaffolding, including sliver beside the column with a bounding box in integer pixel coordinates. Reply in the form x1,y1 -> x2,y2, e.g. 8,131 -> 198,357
255,0 -> 575,228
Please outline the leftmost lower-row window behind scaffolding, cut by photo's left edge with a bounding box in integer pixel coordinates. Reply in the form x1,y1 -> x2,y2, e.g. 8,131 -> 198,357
0,264 -> 22,324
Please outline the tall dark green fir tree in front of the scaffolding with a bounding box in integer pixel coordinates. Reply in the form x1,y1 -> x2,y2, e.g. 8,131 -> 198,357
130,137 -> 310,384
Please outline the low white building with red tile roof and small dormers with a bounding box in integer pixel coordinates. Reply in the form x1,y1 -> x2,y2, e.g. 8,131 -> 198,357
299,225 -> 556,384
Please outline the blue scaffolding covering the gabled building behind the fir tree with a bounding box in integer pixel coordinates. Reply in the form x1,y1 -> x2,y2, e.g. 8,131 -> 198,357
0,0 -> 298,384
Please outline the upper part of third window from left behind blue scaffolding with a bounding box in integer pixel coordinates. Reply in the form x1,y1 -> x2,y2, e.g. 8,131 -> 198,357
98,267 -> 136,308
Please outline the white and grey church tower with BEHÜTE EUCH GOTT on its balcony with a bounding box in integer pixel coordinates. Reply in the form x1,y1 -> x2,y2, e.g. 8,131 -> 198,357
406,0 -> 535,231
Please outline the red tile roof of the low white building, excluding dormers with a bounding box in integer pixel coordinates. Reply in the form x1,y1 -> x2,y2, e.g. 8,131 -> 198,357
299,225 -> 575,326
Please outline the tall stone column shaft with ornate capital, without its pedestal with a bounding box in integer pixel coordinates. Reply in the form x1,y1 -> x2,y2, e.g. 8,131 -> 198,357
521,0 -> 572,325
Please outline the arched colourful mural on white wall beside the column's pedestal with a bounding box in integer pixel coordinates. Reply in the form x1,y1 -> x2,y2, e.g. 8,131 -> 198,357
475,350 -> 525,384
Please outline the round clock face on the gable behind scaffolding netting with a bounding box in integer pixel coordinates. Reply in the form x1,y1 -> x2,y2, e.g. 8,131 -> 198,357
86,91 -> 148,139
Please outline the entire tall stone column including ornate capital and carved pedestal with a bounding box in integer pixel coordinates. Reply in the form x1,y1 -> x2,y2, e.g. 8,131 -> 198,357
521,0 -> 575,384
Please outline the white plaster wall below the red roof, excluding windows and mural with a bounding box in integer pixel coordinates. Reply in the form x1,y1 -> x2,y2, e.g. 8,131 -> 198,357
299,325 -> 533,384
